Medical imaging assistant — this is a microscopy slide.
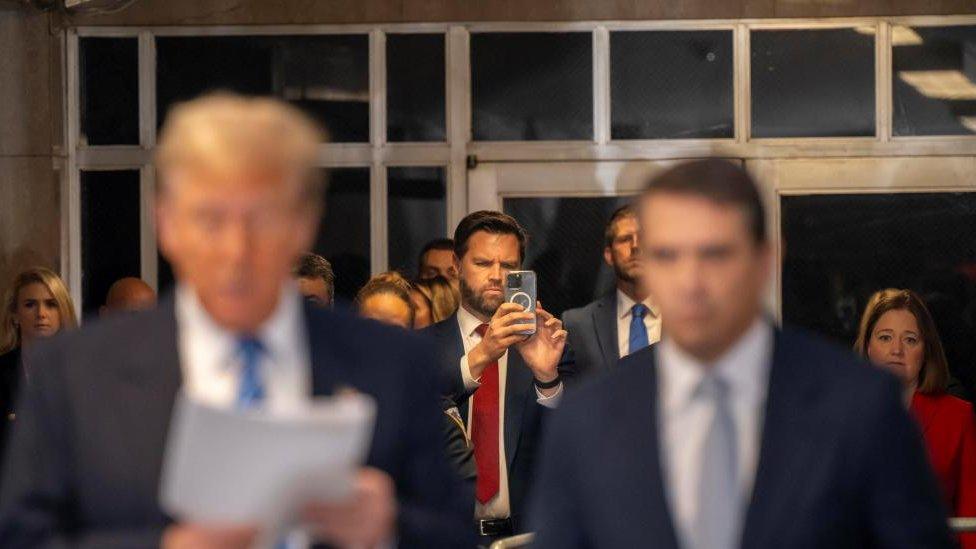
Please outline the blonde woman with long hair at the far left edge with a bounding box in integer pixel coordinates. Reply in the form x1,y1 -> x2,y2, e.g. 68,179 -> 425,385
0,267 -> 78,454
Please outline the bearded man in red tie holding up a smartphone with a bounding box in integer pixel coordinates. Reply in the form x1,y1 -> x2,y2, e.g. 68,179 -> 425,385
426,211 -> 570,545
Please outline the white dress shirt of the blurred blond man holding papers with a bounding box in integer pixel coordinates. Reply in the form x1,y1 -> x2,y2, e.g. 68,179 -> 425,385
176,285 -> 312,414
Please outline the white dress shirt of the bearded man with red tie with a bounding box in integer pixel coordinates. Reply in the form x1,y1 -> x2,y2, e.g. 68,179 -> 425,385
458,306 -> 563,519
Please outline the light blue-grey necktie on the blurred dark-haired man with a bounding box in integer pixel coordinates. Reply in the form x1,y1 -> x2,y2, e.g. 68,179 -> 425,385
691,373 -> 742,549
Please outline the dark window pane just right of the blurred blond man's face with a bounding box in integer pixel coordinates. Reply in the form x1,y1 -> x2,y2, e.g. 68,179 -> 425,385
314,168 -> 370,301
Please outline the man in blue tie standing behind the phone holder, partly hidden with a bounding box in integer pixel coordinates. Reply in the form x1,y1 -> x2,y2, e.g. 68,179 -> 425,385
563,204 -> 661,376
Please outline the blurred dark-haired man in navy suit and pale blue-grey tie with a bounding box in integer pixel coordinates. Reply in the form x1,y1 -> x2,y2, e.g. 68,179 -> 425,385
533,160 -> 952,549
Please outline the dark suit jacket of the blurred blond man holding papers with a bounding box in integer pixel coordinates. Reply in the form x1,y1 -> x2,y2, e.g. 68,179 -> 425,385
0,298 -> 472,549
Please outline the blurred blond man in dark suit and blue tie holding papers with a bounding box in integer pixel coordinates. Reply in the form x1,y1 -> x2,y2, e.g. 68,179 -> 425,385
0,94 -> 473,549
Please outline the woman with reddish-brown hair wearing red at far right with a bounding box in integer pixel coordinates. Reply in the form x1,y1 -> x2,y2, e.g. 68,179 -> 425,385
854,289 -> 976,549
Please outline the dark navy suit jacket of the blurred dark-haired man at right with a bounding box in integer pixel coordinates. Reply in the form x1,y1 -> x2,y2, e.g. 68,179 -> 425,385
532,331 -> 952,549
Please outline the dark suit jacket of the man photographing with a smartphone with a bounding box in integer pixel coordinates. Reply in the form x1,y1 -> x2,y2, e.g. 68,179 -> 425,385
424,314 -> 572,530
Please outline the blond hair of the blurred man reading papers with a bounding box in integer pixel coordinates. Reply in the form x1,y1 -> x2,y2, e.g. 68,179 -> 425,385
156,92 -> 325,196
